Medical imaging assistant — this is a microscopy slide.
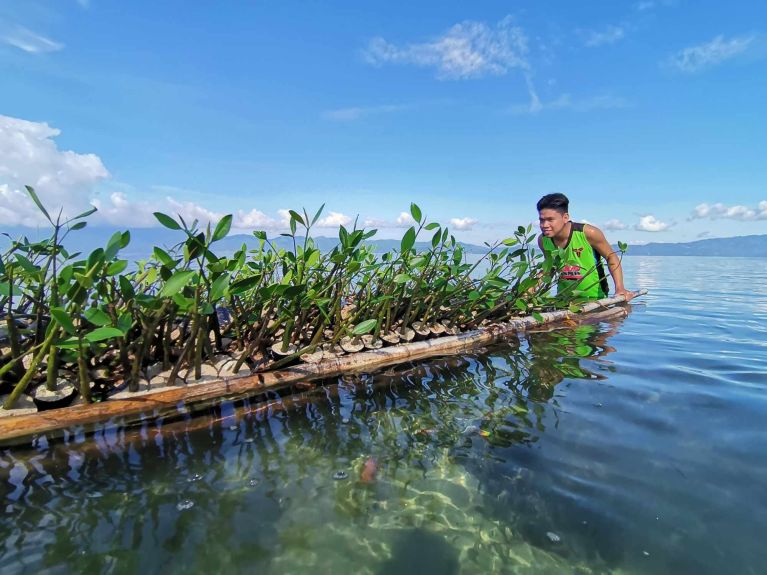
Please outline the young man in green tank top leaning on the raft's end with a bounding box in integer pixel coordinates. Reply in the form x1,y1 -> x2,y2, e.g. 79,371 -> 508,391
537,194 -> 636,301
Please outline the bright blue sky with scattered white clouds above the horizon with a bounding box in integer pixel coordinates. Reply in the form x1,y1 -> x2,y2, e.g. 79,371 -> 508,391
0,0 -> 767,242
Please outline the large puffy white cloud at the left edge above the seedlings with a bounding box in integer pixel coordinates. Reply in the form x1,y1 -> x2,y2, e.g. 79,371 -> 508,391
0,115 -> 109,226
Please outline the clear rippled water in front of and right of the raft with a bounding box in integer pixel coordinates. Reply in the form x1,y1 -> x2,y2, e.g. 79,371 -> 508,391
0,257 -> 767,575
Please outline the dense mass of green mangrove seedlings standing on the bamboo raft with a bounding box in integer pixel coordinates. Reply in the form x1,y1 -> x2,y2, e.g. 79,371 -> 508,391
0,188 -> 628,409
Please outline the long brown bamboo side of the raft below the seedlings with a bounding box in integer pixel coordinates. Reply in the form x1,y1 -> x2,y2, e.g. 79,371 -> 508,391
0,290 -> 647,445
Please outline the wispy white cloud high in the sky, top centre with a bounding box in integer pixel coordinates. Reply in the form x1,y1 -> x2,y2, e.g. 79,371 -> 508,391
364,16 -> 529,80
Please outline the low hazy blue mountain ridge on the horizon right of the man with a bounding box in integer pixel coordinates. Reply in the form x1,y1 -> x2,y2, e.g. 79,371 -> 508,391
626,234 -> 767,257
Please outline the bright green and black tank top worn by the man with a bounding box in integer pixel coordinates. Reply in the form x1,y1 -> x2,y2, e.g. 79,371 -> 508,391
542,222 -> 609,299
